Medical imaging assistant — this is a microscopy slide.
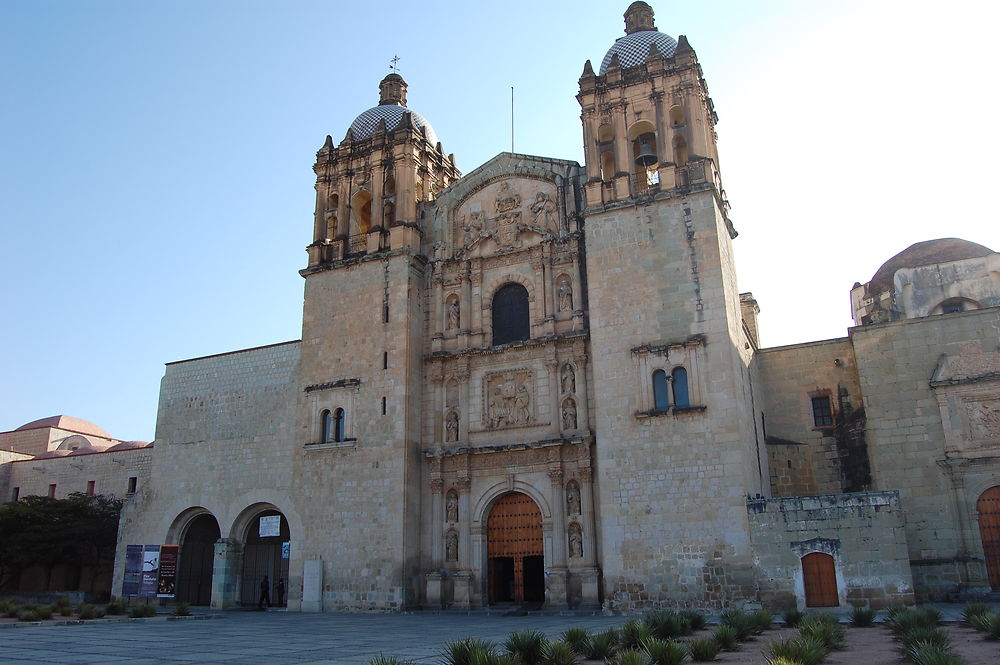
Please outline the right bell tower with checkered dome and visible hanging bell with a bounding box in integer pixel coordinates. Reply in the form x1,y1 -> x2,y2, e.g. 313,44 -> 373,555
577,2 -> 767,611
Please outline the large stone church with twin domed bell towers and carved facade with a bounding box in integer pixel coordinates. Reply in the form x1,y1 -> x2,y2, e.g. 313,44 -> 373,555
95,2 -> 1000,611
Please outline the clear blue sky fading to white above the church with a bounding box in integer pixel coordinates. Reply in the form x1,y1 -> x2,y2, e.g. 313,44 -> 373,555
0,0 -> 1000,440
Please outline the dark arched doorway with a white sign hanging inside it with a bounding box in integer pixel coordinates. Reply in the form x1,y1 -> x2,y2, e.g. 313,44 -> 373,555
240,510 -> 291,606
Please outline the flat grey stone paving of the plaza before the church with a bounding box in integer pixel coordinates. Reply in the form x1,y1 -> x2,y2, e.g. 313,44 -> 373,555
0,605 -> 976,665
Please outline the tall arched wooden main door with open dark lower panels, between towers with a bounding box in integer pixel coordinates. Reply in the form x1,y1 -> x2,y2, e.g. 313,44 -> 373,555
486,492 -> 545,604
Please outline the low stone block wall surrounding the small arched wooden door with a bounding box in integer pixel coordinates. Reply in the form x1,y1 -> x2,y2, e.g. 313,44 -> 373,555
747,492 -> 913,609
